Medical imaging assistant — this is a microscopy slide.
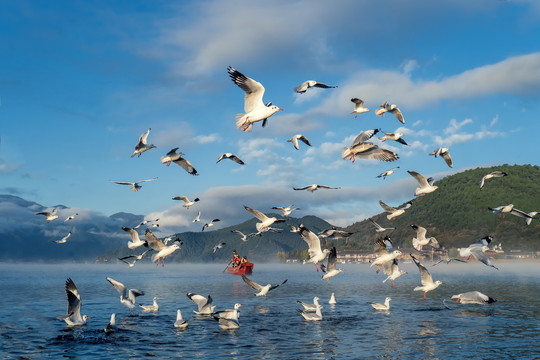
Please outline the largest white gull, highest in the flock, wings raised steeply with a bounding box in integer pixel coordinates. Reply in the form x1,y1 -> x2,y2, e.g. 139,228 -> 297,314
227,66 -> 283,131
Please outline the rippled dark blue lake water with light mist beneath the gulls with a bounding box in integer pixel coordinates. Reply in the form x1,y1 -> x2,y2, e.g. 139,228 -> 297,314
0,261 -> 540,359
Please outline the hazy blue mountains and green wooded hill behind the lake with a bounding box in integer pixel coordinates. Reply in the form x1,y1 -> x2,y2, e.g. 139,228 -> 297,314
0,165 -> 540,263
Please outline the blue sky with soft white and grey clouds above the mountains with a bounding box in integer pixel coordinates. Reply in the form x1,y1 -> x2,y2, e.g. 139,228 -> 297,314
0,0 -> 540,235
